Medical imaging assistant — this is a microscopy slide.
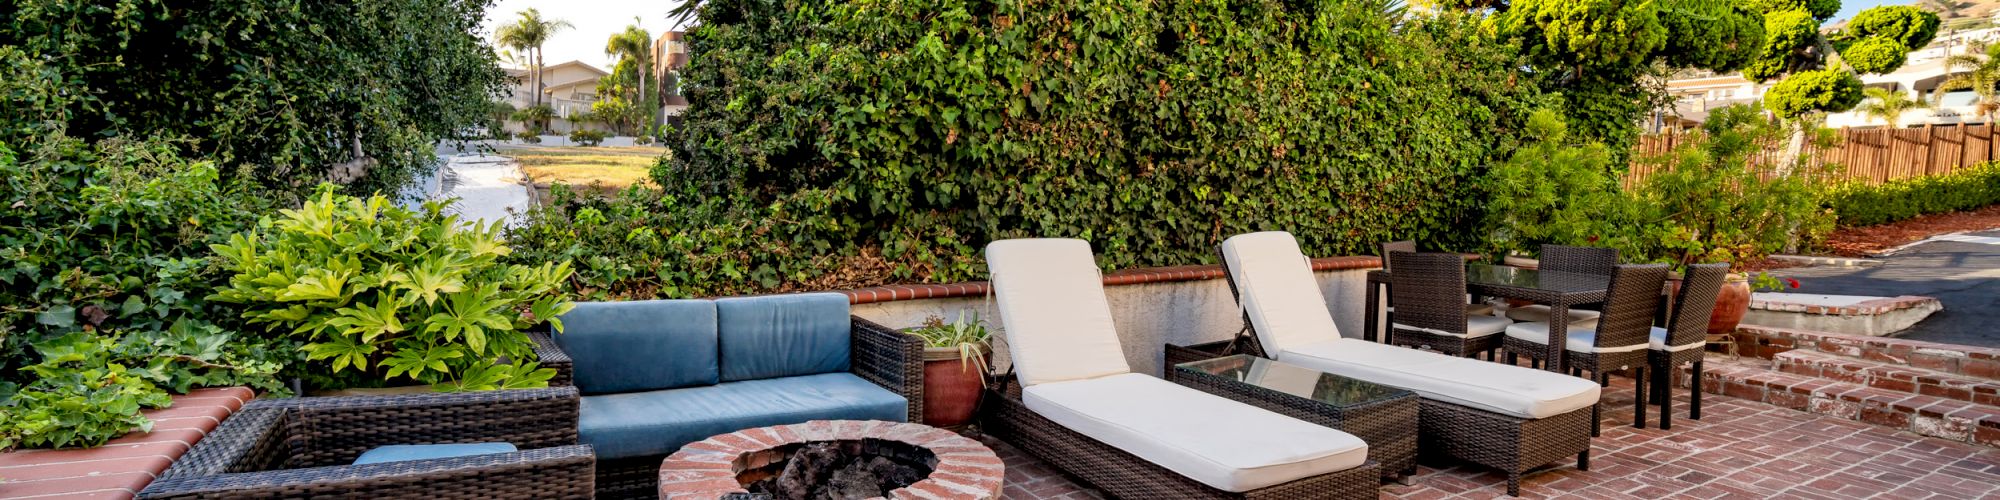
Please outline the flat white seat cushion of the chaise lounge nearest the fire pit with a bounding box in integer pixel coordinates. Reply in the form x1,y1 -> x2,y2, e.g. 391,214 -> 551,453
1022,374 -> 1368,492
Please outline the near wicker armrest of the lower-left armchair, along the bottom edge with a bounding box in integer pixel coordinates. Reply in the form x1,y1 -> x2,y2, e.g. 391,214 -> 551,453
138,446 -> 596,498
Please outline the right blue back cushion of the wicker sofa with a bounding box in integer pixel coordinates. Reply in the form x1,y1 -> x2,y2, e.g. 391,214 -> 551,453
716,294 -> 852,382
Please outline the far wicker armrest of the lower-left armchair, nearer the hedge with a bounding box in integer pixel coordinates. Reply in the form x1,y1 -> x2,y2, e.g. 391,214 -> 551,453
242,386 -> 580,468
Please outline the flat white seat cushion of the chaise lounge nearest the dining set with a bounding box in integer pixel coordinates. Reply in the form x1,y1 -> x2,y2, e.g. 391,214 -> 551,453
1278,338 -> 1600,418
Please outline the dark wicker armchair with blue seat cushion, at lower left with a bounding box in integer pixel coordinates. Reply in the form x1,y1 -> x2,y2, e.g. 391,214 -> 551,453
138,388 -> 596,498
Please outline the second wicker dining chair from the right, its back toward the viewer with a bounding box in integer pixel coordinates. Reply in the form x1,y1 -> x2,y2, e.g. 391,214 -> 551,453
1502,264 -> 1668,436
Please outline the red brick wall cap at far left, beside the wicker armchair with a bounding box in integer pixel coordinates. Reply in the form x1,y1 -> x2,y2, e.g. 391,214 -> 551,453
0,388 -> 256,498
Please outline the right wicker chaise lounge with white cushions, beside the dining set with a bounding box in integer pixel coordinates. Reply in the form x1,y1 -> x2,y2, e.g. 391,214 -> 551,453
1168,232 -> 1600,494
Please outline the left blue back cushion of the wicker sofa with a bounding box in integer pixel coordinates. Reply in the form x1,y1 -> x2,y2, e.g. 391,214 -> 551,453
556,300 -> 720,394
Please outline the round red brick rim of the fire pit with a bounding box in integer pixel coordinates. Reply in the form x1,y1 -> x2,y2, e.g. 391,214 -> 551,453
660,420 -> 1006,500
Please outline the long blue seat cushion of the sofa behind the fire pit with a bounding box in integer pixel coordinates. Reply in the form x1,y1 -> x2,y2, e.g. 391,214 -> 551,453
576,372 -> 910,460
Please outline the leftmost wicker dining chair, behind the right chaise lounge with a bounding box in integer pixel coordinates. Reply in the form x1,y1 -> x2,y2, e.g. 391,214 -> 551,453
1388,252 -> 1510,356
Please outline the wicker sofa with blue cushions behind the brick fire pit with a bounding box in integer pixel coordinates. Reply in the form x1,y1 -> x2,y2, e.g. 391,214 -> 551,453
536,294 -> 924,498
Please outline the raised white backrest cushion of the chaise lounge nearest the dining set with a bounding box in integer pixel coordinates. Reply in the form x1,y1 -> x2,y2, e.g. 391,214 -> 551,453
1222,230 -> 1340,352
